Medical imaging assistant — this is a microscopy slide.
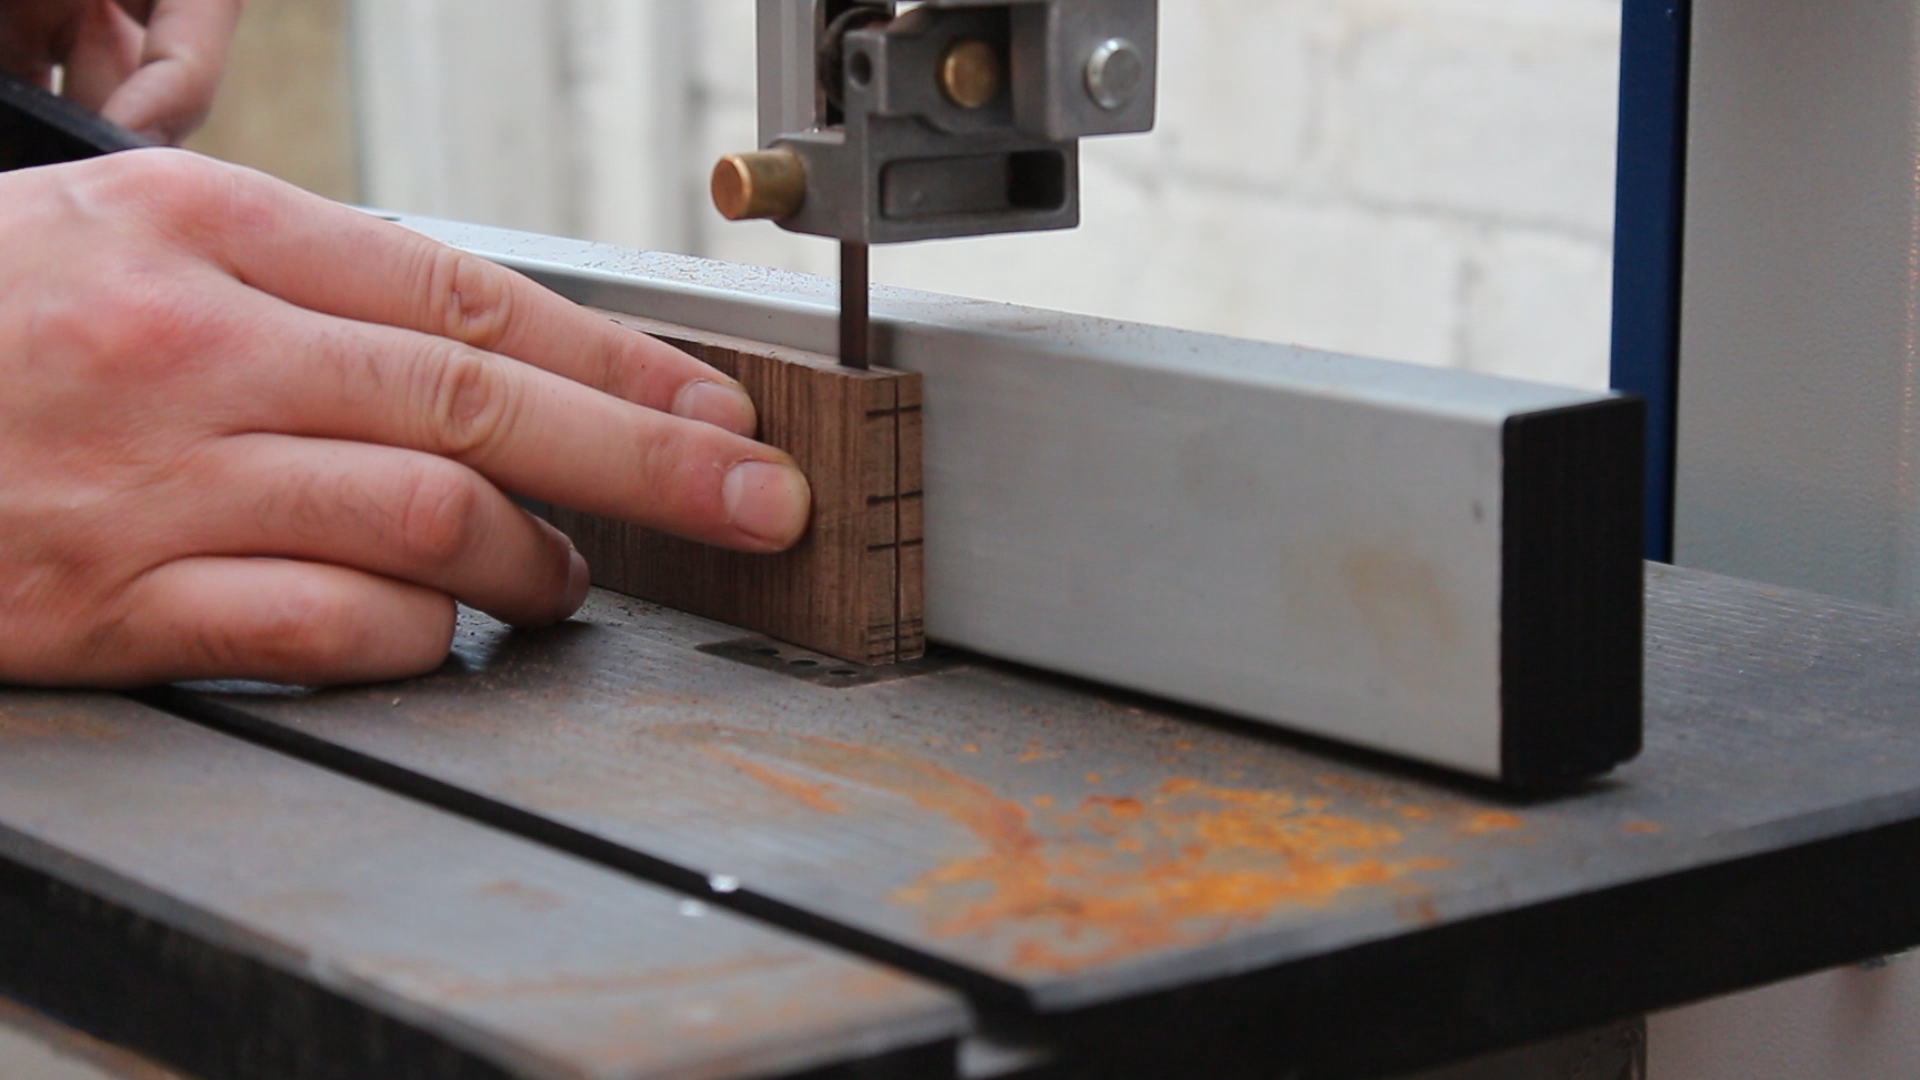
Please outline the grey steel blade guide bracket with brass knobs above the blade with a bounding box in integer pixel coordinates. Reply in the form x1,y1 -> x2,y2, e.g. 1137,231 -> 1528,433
714,0 -> 1160,244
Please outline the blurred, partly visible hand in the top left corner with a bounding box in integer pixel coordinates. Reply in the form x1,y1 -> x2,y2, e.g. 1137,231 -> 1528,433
0,0 -> 242,144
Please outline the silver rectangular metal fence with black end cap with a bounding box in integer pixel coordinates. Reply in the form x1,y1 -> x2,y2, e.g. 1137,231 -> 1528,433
399,217 -> 1642,784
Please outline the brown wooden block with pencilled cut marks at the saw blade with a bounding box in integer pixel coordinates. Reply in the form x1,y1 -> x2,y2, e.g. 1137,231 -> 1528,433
553,311 -> 927,663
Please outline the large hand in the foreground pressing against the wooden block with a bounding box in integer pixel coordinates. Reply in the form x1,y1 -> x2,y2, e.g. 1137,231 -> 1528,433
0,150 -> 808,686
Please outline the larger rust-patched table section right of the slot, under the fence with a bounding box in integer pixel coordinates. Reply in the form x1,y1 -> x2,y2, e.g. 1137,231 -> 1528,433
153,569 -> 1920,1074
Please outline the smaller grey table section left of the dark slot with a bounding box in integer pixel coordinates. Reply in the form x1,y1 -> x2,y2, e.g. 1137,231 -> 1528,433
0,692 -> 970,1080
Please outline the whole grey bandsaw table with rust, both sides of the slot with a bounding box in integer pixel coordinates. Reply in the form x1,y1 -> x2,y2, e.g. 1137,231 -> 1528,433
0,549 -> 1920,1076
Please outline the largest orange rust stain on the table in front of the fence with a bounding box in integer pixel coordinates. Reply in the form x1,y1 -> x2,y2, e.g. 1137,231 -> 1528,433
657,726 -> 1450,972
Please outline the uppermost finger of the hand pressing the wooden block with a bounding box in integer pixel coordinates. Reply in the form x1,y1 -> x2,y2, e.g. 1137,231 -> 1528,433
121,152 -> 758,436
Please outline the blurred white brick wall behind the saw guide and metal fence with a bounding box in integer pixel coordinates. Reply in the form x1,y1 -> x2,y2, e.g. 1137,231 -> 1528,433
357,0 -> 1619,386
